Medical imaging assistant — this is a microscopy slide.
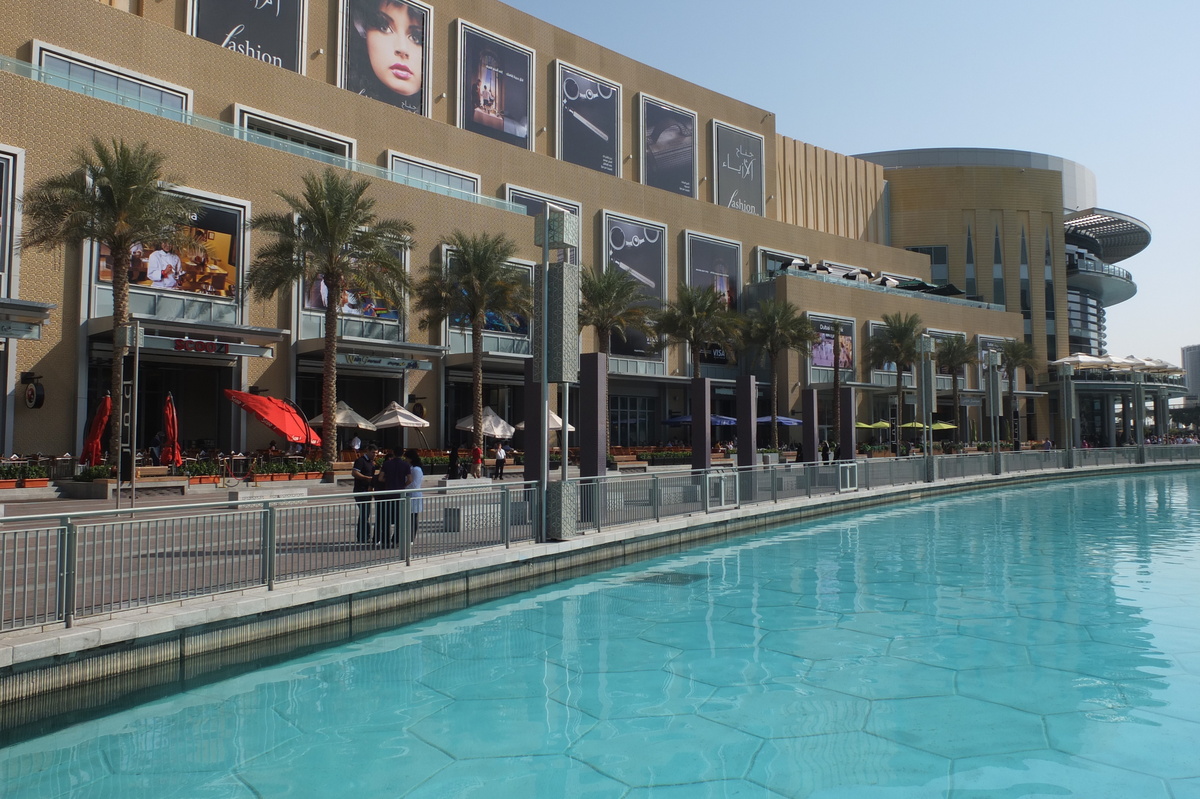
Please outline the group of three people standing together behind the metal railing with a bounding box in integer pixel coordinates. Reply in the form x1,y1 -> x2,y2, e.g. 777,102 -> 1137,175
350,444 -> 425,547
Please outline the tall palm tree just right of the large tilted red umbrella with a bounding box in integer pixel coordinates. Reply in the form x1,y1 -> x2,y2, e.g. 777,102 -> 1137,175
246,167 -> 413,462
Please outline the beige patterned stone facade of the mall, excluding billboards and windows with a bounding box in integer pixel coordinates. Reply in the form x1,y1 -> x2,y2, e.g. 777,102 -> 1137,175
0,0 -> 1104,453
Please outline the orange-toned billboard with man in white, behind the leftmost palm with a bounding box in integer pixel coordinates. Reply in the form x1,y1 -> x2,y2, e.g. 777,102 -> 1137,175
97,195 -> 245,298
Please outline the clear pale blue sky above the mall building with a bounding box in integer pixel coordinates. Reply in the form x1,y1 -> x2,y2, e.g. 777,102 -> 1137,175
508,0 -> 1200,364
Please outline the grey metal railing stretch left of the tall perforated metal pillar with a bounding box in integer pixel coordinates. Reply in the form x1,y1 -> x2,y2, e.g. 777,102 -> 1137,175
0,482 -> 539,630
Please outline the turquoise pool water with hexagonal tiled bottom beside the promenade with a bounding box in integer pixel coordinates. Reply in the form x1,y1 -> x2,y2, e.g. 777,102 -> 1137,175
0,473 -> 1200,799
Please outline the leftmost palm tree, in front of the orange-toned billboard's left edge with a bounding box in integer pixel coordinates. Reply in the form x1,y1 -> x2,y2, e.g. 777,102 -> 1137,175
22,138 -> 196,467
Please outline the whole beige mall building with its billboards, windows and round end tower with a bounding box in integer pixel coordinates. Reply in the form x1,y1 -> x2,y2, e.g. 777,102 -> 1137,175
0,0 -> 1183,455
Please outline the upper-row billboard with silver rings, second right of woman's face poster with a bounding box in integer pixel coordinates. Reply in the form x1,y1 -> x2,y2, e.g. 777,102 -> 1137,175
558,61 -> 620,175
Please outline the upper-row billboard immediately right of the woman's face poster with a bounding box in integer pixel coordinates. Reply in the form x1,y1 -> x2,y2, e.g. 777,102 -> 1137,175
458,20 -> 534,150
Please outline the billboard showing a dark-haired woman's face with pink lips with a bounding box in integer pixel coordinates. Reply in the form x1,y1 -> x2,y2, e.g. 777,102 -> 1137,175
338,0 -> 433,115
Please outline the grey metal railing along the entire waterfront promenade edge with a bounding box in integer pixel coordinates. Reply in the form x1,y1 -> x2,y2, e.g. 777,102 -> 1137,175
0,445 -> 1200,631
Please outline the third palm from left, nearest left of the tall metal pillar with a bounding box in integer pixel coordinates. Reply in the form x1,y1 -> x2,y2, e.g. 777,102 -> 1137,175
416,230 -> 533,450
